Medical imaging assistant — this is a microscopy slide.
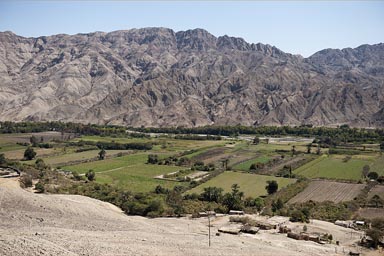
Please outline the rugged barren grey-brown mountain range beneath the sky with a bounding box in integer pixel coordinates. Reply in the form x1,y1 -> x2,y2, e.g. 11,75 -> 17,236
0,28 -> 384,127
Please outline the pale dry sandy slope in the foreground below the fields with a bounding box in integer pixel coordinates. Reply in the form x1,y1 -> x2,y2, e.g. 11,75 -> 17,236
0,178 -> 378,256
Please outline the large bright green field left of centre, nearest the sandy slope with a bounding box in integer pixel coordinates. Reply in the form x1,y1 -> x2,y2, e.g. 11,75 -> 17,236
63,153 -> 186,192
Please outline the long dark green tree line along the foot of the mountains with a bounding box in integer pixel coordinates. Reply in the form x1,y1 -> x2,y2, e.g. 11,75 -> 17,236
0,122 -> 384,145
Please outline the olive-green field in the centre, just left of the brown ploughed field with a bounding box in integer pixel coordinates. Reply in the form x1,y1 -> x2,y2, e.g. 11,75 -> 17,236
187,172 -> 296,197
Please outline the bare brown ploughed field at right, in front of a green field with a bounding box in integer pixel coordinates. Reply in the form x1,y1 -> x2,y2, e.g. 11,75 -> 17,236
288,181 -> 365,204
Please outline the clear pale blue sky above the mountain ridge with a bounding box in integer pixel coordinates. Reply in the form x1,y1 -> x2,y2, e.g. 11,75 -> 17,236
0,0 -> 384,57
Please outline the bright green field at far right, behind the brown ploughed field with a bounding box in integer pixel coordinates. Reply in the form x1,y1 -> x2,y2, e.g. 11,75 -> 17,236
293,155 -> 375,180
